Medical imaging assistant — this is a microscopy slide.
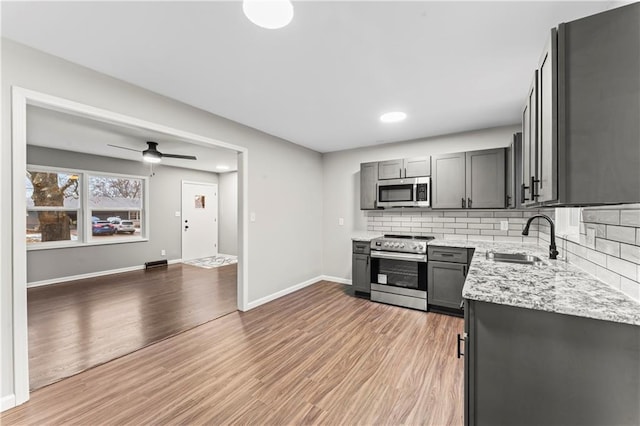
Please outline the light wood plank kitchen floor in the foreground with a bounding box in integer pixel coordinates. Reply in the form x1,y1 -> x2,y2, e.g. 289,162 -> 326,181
5,281 -> 463,425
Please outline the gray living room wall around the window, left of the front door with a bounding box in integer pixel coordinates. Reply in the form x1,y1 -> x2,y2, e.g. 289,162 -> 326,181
27,146 -> 218,283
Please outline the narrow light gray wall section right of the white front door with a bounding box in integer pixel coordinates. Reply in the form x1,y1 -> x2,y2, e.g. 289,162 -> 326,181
218,172 -> 238,256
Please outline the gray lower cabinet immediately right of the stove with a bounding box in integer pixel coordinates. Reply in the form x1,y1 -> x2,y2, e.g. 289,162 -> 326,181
427,246 -> 471,314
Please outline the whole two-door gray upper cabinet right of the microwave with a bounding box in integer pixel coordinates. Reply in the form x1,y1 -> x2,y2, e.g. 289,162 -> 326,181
431,148 -> 506,209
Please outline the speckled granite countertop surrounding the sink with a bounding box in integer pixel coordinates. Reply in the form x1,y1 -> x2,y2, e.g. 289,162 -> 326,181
429,239 -> 640,325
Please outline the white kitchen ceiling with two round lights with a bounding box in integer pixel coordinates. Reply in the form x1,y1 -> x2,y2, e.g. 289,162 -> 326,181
2,1 -> 612,154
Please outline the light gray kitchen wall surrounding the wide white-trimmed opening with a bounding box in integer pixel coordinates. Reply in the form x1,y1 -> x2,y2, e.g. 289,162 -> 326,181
0,39 -> 322,397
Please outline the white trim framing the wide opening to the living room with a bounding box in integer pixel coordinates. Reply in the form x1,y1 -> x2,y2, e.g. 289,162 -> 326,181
12,87 -> 248,405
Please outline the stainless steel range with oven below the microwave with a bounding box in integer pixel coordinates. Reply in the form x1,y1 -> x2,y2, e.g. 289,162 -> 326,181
371,235 -> 433,311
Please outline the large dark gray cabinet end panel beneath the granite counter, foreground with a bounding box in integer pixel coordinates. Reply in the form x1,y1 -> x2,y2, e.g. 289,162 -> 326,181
463,300 -> 640,426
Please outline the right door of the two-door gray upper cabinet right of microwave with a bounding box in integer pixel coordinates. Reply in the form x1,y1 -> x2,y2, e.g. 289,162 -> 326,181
466,148 -> 506,209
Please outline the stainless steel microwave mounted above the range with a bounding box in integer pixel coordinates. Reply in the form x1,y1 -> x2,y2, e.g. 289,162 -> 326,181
377,177 -> 431,208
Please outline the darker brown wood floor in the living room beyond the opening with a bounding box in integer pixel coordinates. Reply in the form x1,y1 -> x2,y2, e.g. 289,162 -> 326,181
27,264 -> 237,389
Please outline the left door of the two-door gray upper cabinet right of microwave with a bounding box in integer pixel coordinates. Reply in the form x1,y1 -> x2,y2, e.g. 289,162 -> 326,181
431,152 -> 467,209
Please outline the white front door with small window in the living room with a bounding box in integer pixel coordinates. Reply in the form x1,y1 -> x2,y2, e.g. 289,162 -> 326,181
181,181 -> 218,260
